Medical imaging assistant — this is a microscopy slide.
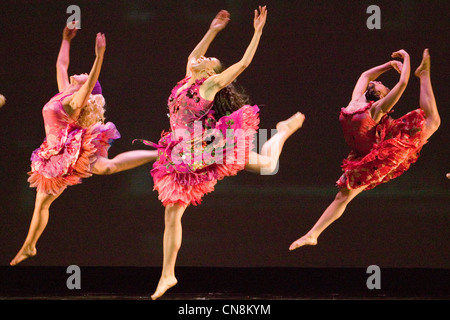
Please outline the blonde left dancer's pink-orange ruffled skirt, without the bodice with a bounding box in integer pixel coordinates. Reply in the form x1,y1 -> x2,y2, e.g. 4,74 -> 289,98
28,122 -> 120,195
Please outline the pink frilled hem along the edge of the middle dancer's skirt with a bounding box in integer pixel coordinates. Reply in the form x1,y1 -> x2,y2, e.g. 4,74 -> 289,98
151,105 -> 259,206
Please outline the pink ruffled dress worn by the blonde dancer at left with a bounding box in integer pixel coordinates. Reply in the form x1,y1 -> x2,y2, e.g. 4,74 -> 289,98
28,93 -> 120,195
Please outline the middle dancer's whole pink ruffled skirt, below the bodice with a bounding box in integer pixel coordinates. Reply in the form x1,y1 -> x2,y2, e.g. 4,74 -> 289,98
147,105 -> 259,206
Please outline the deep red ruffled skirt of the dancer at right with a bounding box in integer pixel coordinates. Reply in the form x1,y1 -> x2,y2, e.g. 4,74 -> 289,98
336,109 -> 427,190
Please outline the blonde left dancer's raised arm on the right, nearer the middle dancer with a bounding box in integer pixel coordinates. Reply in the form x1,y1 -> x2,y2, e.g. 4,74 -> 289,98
70,33 -> 106,110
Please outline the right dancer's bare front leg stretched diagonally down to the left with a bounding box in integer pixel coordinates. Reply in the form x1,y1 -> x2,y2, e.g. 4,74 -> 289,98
289,187 -> 365,250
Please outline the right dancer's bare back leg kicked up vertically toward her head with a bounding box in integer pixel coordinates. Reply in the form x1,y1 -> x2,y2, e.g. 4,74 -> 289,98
415,49 -> 441,140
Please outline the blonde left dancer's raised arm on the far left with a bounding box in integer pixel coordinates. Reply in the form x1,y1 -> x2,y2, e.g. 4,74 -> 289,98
56,22 -> 77,92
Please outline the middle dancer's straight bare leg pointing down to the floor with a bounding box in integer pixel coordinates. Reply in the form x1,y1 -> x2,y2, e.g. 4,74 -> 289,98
152,204 -> 186,300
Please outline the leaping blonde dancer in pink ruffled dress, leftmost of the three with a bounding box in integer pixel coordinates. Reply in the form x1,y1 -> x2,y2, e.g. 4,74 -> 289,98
10,26 -> 157,265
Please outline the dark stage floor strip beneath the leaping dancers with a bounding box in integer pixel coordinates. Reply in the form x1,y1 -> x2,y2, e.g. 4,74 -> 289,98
0,266 -> 450,301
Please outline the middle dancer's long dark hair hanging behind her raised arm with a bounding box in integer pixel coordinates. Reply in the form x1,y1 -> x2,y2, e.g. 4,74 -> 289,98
212,63 -> 250,119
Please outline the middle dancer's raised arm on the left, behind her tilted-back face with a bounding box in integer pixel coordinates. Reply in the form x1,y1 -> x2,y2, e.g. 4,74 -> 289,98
186,10 -> 230,76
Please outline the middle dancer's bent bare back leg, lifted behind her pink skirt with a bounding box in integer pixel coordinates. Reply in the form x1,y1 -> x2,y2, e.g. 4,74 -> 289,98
245,112 -> 305,175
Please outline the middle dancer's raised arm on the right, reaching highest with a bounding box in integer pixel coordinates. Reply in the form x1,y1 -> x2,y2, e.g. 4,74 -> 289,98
200,6 -> 267,99
